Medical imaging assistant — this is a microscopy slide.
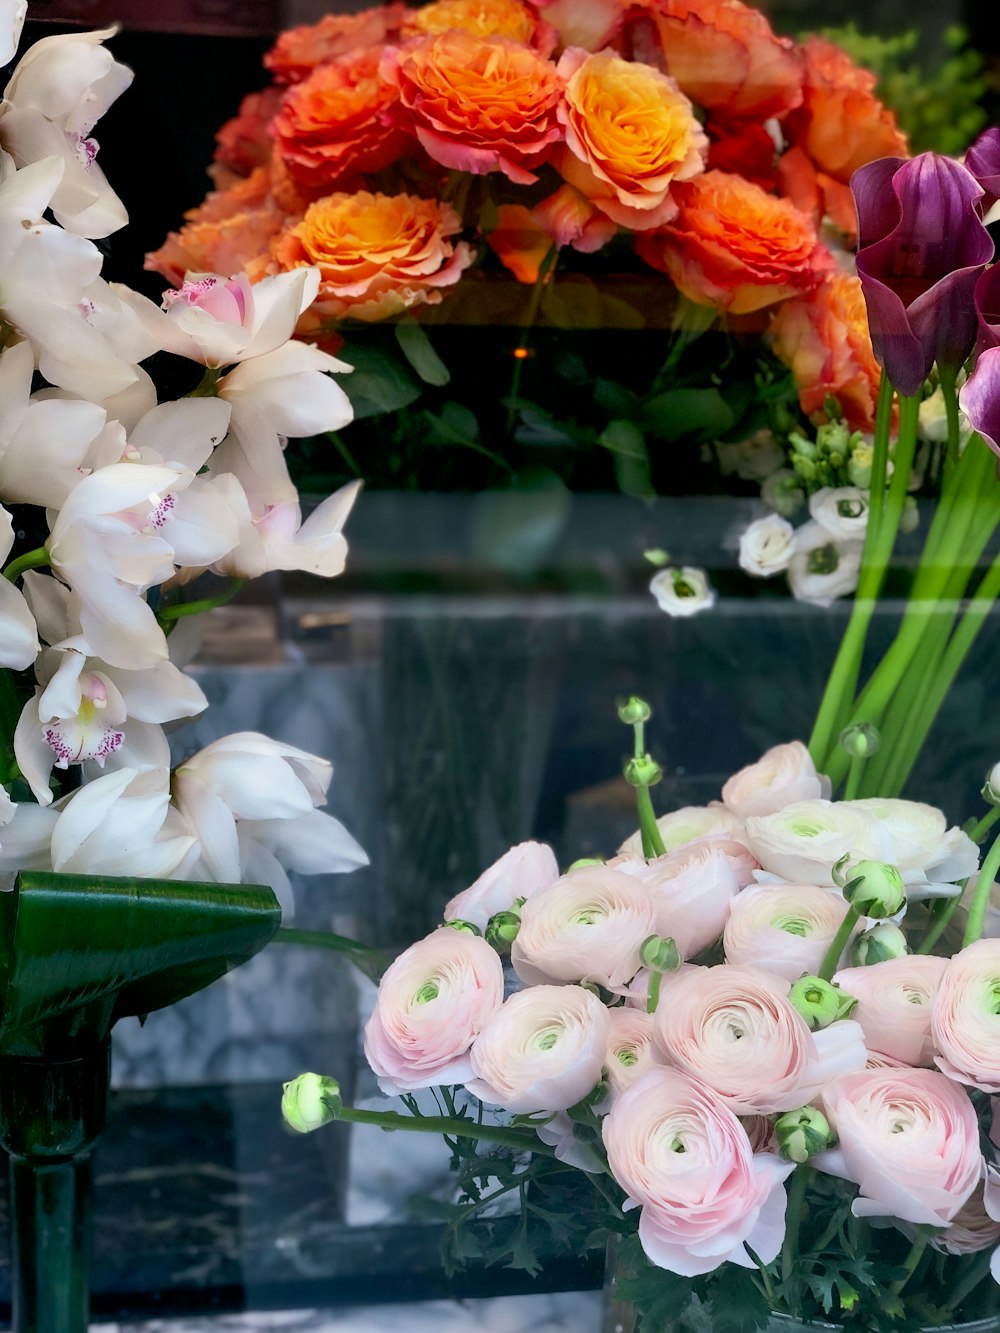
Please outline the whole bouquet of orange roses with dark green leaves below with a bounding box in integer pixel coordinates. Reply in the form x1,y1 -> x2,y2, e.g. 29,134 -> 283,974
147,0 -> 922,495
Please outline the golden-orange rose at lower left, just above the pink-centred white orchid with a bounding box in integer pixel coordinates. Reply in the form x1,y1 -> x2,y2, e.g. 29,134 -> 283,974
264,191 -> 473,325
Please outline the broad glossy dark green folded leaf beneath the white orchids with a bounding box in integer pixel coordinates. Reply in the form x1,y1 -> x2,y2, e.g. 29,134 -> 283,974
0,870 -> 281,1058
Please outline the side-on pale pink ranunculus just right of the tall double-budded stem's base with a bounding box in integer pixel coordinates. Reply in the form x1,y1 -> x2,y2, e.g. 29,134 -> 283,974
616,837 -> 743,958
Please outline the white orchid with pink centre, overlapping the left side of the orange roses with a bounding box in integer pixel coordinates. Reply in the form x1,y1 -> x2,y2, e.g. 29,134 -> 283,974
112,268 -> 320,369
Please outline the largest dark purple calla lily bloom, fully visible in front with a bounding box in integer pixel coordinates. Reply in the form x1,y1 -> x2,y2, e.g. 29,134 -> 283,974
851,153 -> 993,396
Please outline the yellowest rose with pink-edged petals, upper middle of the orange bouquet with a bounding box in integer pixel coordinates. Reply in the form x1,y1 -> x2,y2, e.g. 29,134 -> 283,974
557,49 -> 708,231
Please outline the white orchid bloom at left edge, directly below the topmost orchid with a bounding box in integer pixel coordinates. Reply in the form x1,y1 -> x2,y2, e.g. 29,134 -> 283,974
0,152 -> 136,400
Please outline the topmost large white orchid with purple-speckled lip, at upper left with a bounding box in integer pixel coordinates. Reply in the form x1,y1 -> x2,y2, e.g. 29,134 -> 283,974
0,28 -> 133,239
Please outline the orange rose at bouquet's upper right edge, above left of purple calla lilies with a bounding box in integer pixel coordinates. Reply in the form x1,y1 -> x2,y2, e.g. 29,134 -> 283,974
784,37 -> 908,184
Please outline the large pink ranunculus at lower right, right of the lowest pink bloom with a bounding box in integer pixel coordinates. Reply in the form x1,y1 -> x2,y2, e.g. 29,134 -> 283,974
812,1069 -> 983,1226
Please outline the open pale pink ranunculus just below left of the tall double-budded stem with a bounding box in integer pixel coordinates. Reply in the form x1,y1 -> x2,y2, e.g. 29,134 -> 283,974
511,865 -> 656,988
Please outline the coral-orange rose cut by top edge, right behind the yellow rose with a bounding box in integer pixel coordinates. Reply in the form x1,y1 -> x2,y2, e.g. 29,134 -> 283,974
645,0 -> 803,121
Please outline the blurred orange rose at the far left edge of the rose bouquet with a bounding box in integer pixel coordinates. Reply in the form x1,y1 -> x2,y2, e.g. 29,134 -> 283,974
143,167 -> 285,287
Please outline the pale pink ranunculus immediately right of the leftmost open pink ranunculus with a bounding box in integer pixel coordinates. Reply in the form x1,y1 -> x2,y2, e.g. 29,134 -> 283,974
465,985 -> 611,1116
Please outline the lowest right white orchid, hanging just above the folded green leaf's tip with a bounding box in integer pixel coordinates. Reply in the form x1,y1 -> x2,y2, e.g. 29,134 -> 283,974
172,732 -> 368,906
